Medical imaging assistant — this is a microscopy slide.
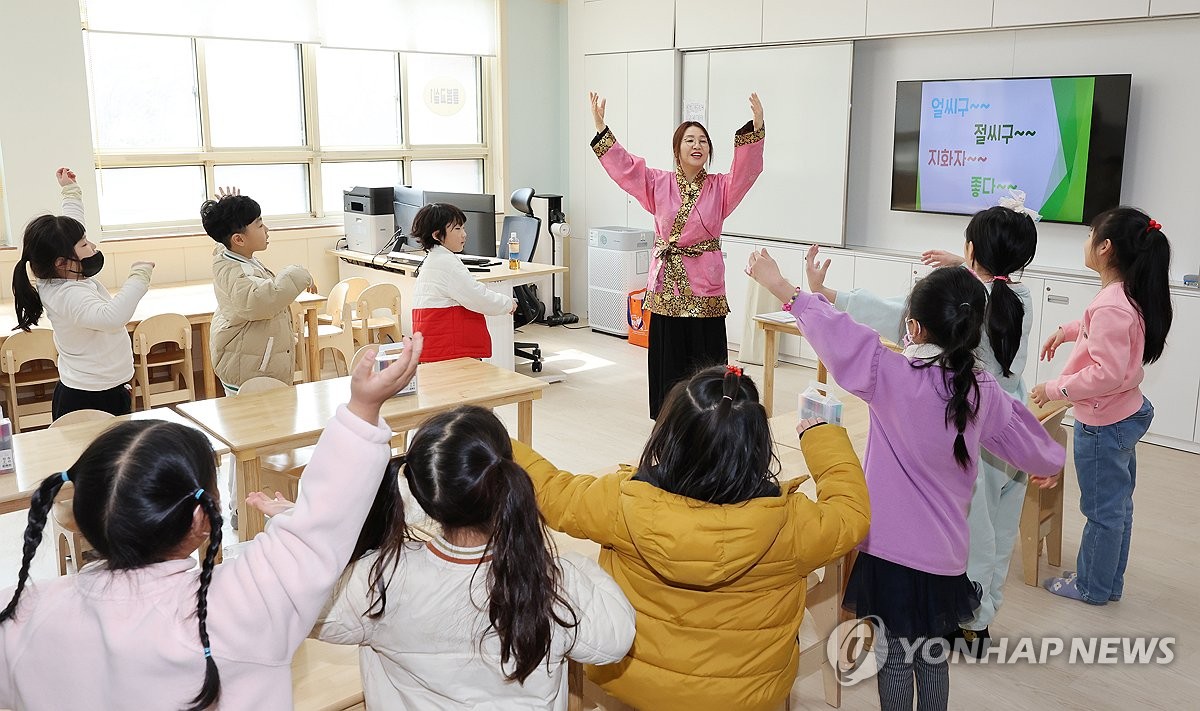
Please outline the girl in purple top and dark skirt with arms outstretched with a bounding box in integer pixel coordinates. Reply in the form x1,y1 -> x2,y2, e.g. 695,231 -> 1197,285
746,250 -> 1066,710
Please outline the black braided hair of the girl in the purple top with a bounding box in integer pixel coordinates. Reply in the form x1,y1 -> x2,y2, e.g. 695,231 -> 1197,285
908,268 -> 988,468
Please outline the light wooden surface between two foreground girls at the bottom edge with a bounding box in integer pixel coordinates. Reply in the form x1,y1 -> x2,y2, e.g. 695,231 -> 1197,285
292,639 -> 366,711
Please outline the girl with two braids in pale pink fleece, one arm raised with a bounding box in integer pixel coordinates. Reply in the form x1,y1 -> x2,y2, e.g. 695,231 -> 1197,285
0,335 -> 421,711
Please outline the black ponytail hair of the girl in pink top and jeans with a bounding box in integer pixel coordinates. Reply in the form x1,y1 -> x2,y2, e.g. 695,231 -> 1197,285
1092,208 -> 1174,364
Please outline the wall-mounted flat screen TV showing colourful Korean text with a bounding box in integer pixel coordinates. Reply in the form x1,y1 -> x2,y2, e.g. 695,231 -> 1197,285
892,74 -> 1129,223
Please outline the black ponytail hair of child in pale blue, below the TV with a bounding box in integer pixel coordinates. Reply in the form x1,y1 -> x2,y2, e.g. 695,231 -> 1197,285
966,207 -> 1038,377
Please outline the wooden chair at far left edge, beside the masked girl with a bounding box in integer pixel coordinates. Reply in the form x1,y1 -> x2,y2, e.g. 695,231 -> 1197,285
0,328 -> 59,434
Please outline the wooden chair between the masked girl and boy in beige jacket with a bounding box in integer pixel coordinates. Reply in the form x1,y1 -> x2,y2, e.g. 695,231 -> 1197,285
133,313 -> 196,410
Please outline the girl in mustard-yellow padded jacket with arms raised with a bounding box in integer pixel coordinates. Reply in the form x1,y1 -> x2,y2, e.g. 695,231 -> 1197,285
512,365 -> 870,711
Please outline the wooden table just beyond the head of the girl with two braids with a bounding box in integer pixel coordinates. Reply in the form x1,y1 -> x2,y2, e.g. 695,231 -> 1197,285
0,407 -> 229,514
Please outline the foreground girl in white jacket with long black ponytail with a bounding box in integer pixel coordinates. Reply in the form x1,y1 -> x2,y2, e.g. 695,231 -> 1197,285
298,406 -> 634,710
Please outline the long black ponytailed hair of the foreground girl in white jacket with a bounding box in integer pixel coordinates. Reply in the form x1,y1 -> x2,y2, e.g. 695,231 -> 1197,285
398,406 -> 578,682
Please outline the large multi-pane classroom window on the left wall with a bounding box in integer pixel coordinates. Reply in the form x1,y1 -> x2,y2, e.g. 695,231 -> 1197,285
84,31 -> 496,234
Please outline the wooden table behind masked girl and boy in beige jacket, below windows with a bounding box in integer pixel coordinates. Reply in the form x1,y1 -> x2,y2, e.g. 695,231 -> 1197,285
0,281 -> 325,398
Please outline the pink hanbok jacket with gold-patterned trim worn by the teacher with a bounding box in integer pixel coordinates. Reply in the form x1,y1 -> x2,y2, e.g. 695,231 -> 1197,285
592,123 -> 766,316
